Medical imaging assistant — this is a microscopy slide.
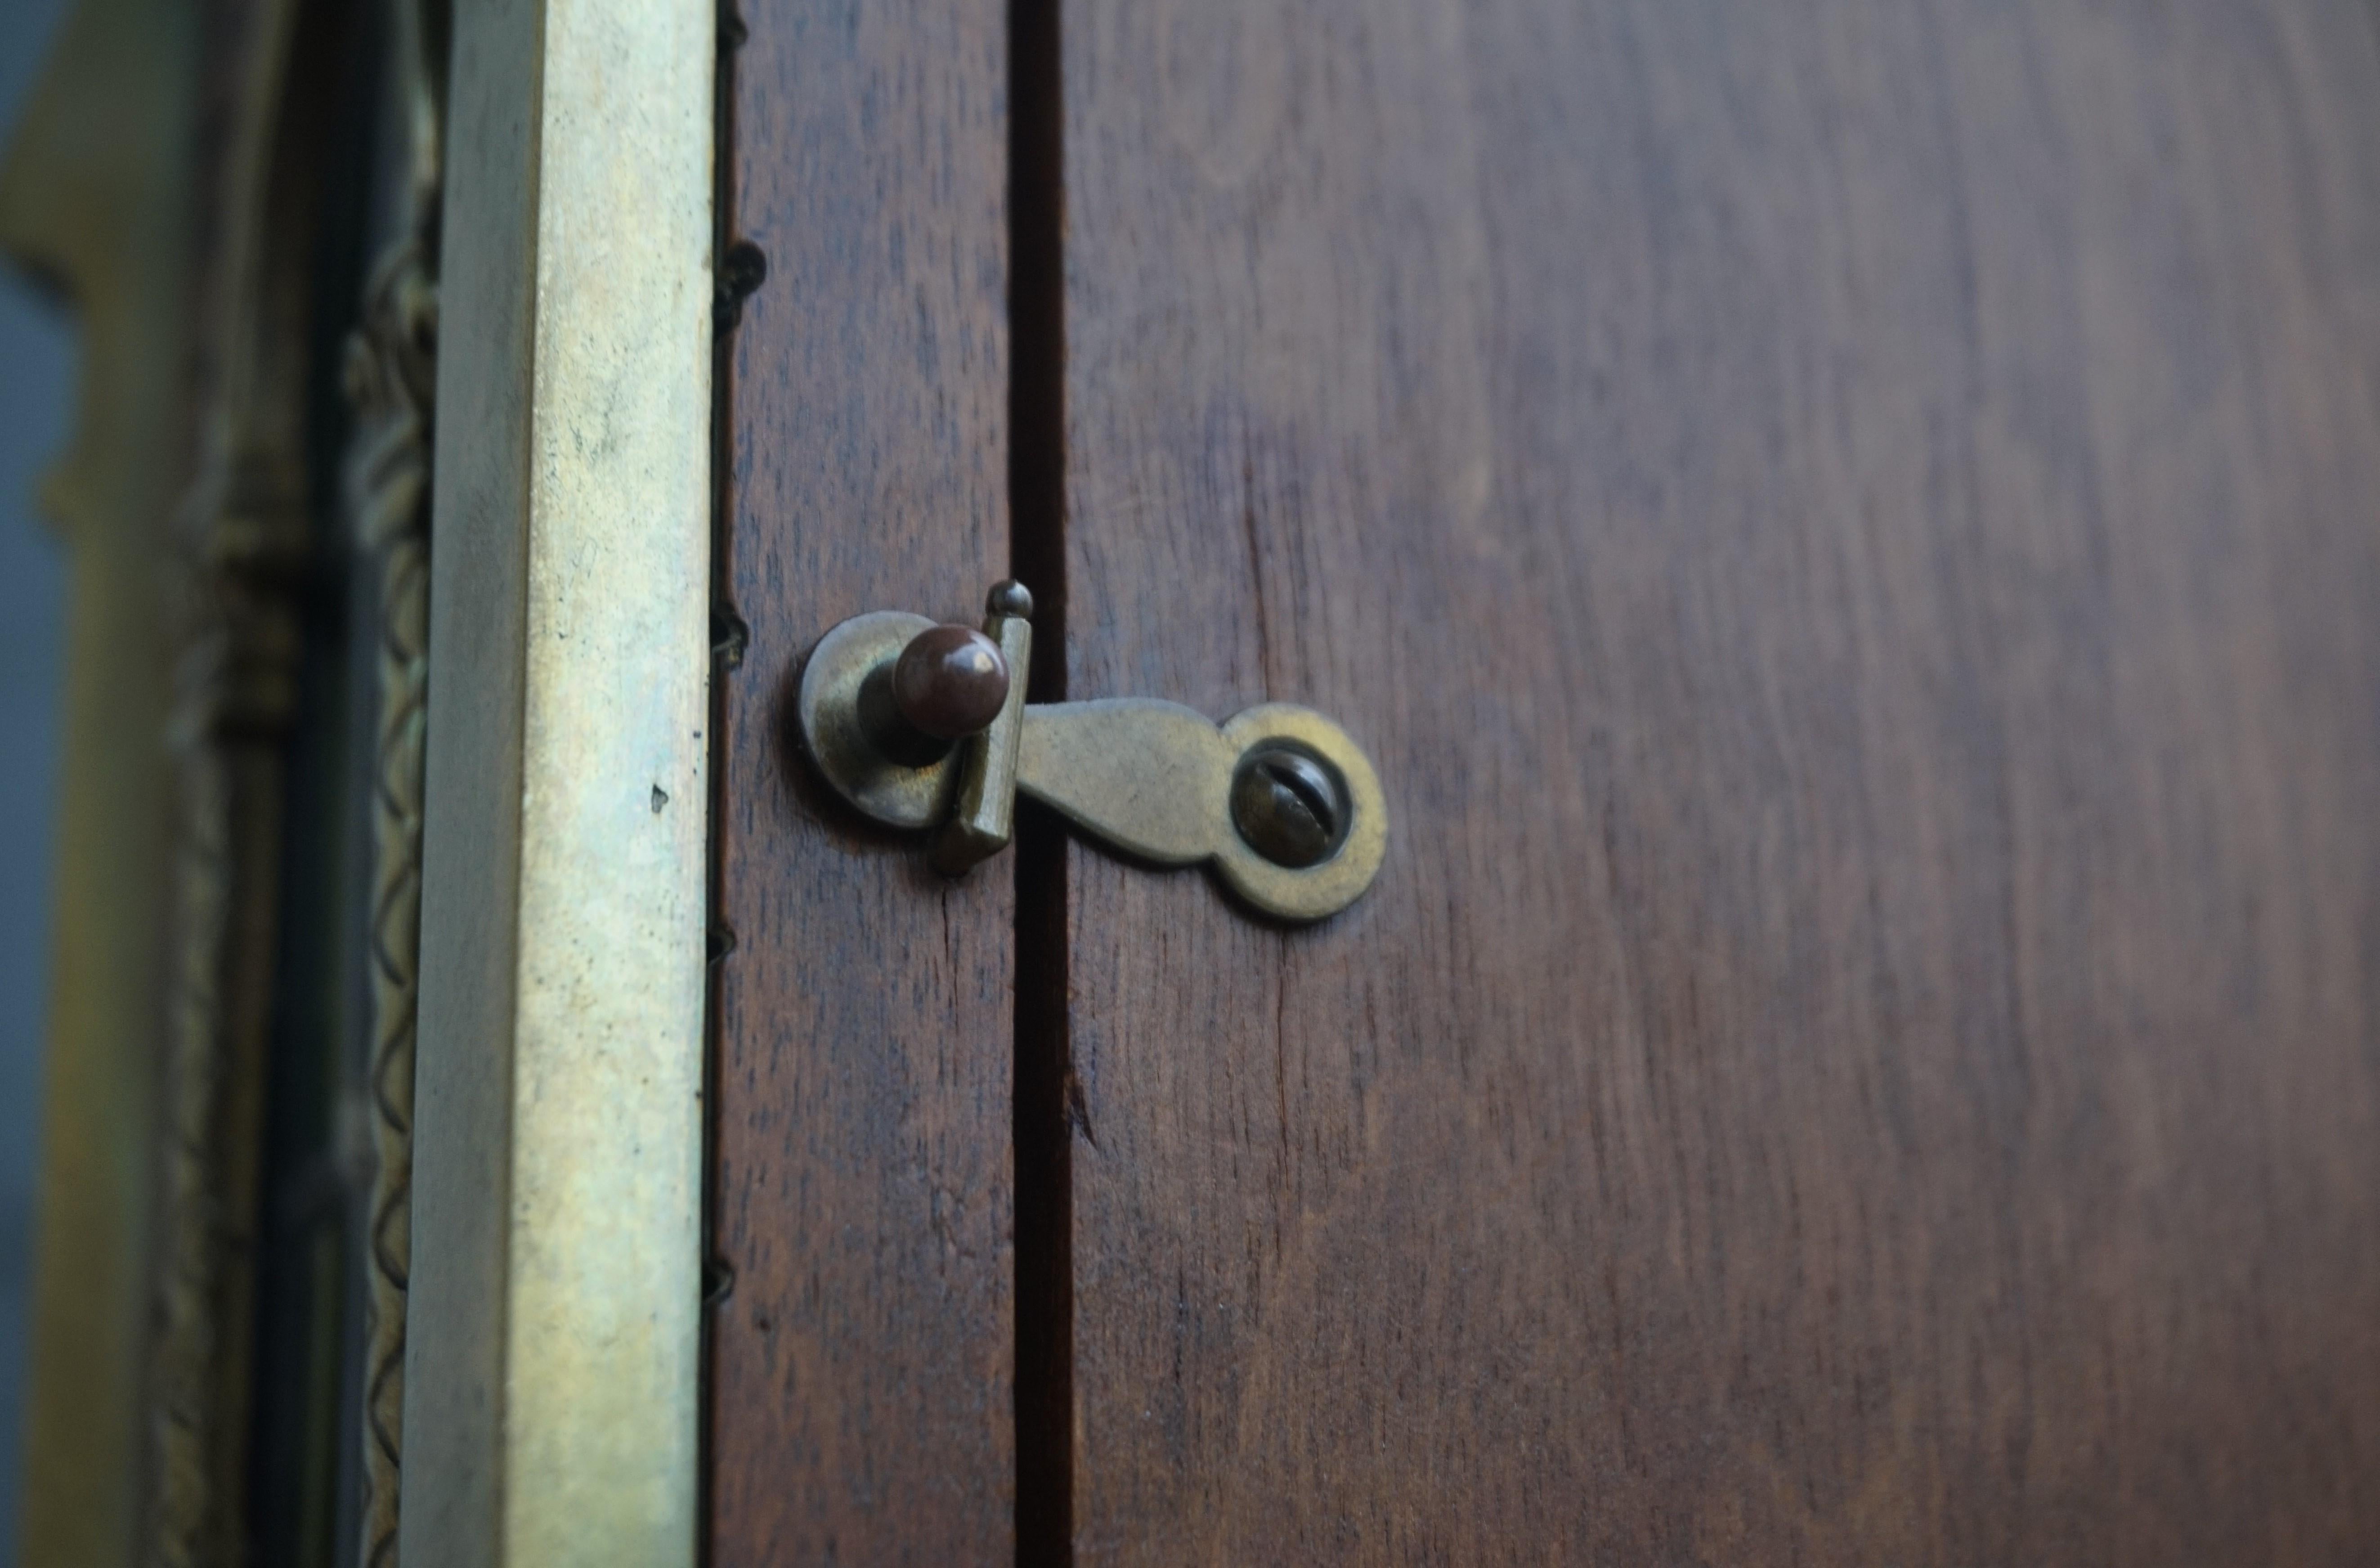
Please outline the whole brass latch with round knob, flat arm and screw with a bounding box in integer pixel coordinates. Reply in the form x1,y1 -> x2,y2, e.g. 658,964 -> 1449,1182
797,583 -> 1388,921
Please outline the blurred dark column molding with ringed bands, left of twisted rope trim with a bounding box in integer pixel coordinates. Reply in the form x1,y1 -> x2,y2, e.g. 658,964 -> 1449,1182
145,0 -> 352,1568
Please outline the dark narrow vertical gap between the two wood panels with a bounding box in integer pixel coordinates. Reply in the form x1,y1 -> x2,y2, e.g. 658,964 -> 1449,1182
1009,0 -> 1073,1568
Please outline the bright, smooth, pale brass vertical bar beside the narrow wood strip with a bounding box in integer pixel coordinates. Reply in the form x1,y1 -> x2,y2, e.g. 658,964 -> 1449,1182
400,0 -> 717,1568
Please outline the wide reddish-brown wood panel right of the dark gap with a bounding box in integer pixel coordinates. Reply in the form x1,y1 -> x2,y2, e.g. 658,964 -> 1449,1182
1052,0 -> 2380,1566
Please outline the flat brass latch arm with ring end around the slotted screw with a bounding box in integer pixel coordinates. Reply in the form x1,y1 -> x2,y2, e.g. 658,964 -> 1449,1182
1016,697 -> 1388,921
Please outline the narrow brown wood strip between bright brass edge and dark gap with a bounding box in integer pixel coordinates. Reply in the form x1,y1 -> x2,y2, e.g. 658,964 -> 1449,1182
707,0 -> 1014,1568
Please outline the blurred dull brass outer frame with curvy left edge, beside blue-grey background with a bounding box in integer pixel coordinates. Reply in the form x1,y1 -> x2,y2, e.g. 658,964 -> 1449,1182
0,0 -> 197,1568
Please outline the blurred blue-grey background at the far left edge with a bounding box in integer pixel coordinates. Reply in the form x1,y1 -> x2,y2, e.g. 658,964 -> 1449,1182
0,0 -> 74,1563
